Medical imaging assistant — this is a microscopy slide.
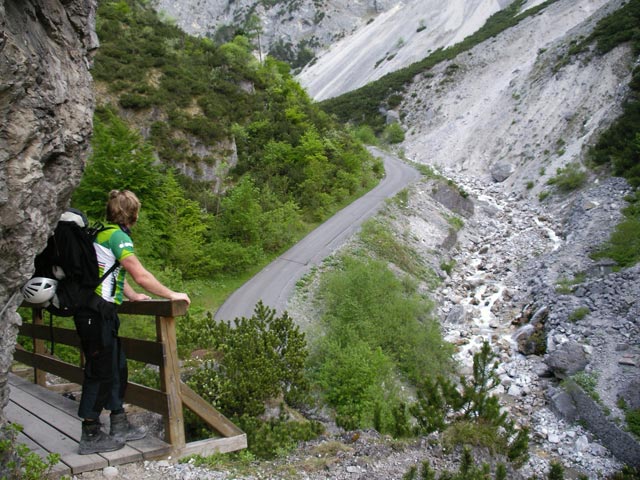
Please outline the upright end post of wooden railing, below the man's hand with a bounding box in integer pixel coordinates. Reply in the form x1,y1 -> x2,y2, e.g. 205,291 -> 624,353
156,316 -> 186,450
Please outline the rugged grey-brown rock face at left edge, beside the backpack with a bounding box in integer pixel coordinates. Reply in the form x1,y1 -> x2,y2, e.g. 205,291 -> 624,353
0,0 -> 98,424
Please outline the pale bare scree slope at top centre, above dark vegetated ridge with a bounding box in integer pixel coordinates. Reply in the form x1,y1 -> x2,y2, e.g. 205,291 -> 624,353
298,0 -> 524,100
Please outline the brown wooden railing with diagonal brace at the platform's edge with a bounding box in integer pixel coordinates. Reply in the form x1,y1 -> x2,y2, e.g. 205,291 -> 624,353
14,300 -> 247,456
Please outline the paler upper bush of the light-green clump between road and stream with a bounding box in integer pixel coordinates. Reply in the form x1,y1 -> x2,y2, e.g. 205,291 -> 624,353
319,256 -> 452,382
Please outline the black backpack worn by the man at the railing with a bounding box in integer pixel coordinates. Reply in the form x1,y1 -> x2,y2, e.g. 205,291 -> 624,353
34,208 -> 119,317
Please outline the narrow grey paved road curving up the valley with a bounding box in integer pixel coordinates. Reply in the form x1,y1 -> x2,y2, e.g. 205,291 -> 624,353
215,149 -> 420,320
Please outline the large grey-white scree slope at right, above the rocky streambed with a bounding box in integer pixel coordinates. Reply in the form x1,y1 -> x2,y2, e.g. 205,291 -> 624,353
401,0 -> 632,193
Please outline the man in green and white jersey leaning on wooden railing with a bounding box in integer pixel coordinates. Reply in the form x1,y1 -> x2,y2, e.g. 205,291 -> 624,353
74,190 -> 190,455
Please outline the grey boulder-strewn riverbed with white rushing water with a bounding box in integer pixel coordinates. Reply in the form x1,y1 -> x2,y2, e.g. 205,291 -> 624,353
428,171 -> 640,478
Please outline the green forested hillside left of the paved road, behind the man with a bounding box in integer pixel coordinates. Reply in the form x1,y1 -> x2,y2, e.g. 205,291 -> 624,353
74,0 -> 382,279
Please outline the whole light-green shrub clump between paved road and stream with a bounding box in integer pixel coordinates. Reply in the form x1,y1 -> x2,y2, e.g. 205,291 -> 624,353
309,256 -> 451,436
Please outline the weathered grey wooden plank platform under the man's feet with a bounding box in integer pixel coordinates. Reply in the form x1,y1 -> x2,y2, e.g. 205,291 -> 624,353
5,374 -> 171,476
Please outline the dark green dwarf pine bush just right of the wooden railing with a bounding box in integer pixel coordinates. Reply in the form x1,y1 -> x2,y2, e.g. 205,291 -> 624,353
185,302 -> 308,430
